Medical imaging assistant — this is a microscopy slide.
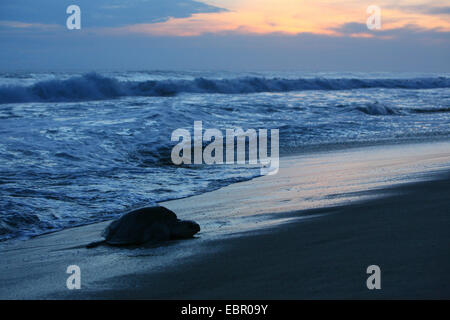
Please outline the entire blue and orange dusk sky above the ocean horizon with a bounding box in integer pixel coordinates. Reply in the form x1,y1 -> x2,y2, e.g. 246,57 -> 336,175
0,0 -> 450,72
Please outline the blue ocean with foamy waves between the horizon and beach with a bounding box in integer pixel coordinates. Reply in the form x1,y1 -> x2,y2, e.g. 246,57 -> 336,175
0,71 -> 450,241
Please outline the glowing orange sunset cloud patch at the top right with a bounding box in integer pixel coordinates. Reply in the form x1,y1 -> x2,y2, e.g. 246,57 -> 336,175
116,0 -> 450,37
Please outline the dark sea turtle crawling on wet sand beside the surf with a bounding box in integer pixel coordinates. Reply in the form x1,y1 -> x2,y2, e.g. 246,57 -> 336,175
86,206 -> 200,248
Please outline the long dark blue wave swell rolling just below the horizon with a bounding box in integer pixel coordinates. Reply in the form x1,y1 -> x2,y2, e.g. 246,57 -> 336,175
0,73 -> 450,104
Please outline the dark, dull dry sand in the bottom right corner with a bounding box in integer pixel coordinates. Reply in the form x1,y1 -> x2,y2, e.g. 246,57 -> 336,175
75,178 -> 450,299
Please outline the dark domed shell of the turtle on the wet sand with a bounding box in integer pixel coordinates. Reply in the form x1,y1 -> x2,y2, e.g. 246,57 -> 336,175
102,206 -> 178,245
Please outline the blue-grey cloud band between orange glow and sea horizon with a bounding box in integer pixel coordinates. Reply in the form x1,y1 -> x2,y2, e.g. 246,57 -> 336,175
0,28 -> 450,72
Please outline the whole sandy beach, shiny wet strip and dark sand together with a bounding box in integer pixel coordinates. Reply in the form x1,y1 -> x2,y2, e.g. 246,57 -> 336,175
0,143 -> 450,299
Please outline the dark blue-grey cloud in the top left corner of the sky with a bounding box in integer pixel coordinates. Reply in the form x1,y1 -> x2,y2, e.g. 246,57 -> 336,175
0,0 -> 225,28
